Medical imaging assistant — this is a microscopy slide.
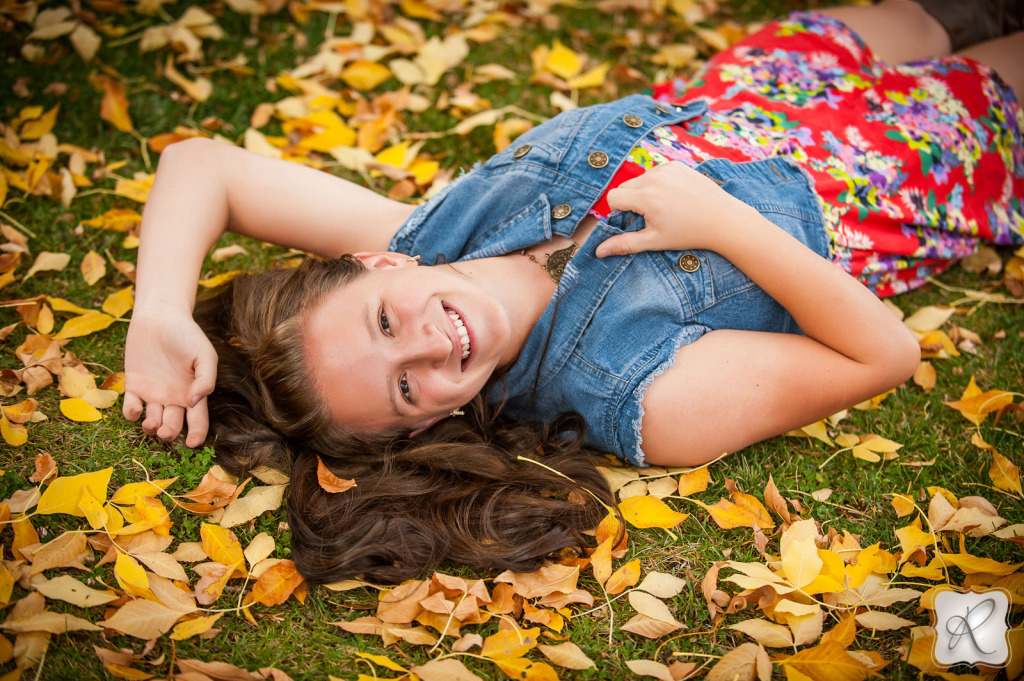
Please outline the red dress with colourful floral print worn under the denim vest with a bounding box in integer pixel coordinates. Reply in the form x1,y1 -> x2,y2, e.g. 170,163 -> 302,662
595,12 -> 1024,295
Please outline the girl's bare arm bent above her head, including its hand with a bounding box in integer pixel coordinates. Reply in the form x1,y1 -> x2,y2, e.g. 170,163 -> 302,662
123,139 -> 413,446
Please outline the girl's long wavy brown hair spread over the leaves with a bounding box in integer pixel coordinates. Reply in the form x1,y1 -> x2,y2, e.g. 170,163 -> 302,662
195,256 -> 614,582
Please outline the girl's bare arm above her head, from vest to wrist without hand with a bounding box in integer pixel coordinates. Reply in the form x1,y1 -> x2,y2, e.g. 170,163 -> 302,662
136,139 -> 415,310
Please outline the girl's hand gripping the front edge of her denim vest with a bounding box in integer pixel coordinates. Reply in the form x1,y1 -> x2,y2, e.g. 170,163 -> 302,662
597,162 -> 756,258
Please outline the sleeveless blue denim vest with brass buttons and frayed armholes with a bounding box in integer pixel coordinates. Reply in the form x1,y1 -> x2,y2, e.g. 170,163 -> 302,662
391,95 -> 828,465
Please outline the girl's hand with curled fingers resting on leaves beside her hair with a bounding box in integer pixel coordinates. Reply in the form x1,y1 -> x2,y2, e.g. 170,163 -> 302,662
122,311 -> 217,446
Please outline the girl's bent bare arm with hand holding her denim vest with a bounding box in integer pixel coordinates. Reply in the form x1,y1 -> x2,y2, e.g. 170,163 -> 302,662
599,164 -> 921,465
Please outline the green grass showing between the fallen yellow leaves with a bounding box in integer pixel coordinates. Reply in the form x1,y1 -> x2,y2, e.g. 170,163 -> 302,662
0,0 -> 1024,681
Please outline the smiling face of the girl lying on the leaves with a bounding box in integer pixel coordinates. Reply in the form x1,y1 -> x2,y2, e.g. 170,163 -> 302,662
303,254 -> 515,433
